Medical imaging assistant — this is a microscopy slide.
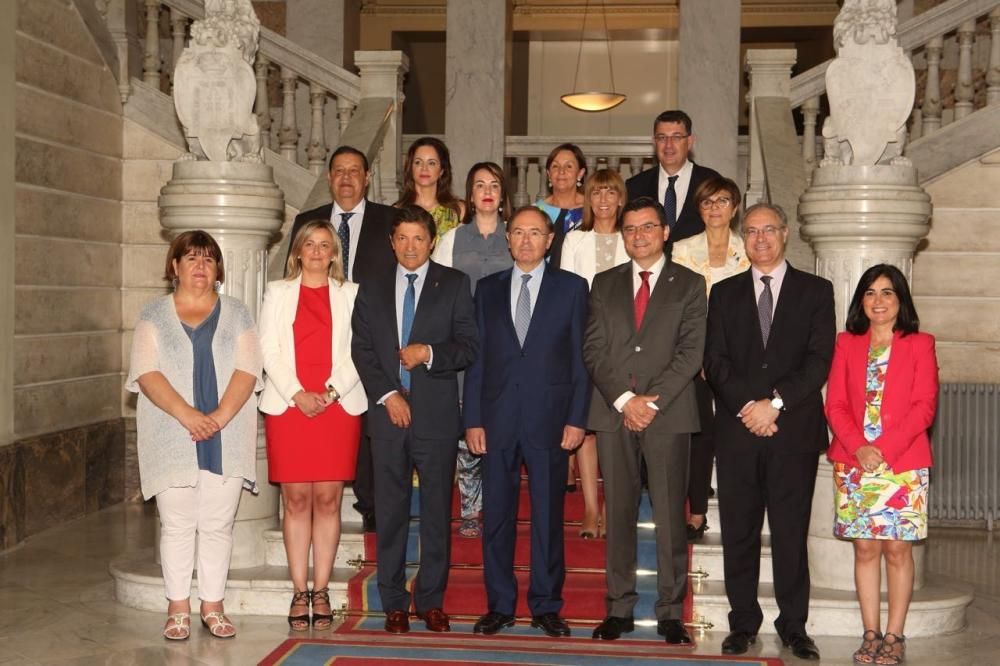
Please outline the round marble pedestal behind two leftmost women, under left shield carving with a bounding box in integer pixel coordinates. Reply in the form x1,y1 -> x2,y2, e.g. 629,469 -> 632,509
159,161 -> 285,569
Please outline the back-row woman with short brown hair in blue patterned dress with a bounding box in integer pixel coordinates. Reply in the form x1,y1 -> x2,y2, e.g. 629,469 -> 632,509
535,143 -> 587,268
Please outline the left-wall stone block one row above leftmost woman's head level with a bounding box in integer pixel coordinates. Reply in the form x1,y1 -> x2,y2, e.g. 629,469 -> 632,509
14,186 -> 122,243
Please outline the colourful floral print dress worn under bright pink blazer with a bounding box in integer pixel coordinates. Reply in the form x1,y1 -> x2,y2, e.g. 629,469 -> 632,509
833,346 -> 929,541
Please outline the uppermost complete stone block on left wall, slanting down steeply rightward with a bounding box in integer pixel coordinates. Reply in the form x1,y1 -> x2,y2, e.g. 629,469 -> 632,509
15,35 -> 122,114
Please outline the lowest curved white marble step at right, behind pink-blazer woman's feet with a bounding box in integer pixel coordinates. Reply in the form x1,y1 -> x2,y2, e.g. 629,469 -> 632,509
693,576 -> 972,638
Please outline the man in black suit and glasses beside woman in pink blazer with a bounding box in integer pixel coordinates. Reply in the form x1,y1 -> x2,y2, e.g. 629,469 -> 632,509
705,204 -> 836,659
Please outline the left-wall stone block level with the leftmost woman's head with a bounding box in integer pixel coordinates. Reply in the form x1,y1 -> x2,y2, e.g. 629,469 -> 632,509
14,236 -> 122,287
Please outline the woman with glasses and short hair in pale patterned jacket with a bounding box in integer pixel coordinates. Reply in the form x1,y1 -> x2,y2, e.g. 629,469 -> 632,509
671,176 -> 750,541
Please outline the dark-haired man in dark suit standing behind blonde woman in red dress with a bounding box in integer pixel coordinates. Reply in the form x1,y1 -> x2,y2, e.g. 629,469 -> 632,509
286,146 -> 397,532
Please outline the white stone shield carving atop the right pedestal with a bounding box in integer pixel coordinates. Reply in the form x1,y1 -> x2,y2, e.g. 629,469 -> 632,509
821,0 -> 916,166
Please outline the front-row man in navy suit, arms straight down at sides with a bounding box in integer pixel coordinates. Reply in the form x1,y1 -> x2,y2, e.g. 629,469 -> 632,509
463,206 -> 590,637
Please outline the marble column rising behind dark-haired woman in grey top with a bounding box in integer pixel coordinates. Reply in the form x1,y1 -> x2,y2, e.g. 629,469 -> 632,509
445,0 -> 513,195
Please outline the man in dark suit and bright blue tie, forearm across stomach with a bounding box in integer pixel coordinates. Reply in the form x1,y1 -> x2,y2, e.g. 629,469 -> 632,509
351,206 -> 479,633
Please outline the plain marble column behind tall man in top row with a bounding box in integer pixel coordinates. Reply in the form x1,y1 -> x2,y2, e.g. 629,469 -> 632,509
677,0 -> 740,178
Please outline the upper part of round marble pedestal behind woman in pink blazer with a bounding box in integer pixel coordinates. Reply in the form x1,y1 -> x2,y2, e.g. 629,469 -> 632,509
799,165 -> 931,330
